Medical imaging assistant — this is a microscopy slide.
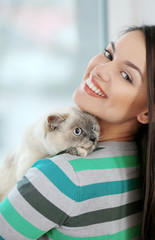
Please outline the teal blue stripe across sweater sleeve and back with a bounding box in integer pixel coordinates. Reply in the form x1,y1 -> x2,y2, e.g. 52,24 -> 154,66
33,159 -> 140,202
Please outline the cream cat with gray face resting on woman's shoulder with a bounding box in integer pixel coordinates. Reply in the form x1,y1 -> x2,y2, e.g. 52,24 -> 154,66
0,107 -> 100,202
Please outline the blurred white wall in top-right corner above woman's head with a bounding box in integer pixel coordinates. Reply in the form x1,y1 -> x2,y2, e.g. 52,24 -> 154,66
107,0 -> 155,40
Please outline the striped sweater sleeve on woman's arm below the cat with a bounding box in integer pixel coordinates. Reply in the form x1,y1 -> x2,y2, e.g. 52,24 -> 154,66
0,156 -> 78,240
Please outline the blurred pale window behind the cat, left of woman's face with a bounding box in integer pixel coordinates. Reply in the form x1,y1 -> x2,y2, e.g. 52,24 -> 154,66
0,0 -> 106,159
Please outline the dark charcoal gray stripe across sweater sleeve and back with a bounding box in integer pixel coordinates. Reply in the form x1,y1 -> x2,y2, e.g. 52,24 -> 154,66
17,176 -> 141,227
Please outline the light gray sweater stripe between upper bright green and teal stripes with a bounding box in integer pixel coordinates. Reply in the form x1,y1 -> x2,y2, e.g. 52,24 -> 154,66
50,154 -> 140,186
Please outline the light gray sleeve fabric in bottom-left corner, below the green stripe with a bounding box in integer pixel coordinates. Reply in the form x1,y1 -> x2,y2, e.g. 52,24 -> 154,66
0,213 -> 30,240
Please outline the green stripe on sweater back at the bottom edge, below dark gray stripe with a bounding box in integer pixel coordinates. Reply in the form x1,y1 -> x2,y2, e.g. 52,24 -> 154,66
47,225 -> 141,240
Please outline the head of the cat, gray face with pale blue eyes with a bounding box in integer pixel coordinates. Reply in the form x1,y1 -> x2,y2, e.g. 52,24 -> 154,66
46,107 -> 100,152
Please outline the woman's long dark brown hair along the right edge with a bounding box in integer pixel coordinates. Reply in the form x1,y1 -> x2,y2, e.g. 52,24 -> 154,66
125,25 -> 155,240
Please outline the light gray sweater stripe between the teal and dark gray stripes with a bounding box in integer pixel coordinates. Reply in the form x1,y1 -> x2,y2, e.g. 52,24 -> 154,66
26,168 -> 142,216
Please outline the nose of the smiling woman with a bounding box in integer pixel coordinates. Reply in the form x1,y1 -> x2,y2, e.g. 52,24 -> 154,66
92,63 -> 111,82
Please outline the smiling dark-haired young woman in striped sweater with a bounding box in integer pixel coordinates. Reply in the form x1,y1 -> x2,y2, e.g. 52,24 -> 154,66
0,26 -> 155,240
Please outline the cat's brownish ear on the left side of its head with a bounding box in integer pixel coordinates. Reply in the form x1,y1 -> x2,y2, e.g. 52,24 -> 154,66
47,114 -> 68,131
